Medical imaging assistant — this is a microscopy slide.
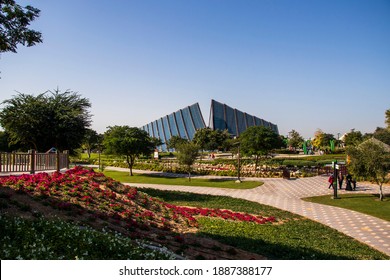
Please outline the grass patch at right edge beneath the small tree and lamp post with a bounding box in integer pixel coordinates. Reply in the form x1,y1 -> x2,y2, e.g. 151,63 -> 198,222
304,194 -> 390,222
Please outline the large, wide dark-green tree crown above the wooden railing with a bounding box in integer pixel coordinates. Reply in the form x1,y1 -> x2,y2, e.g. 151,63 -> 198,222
0,89 -> 91,152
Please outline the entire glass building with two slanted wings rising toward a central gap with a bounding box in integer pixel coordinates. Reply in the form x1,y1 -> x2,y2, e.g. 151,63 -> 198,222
141,100 -> 279,151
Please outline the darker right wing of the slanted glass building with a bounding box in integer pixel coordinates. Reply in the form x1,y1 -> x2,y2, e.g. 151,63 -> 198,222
209,100 -> 279,136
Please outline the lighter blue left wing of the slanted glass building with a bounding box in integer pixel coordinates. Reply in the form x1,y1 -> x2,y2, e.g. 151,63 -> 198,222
141,103 -> 206,151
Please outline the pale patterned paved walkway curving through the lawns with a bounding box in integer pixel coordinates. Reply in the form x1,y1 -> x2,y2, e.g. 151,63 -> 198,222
106,167 -> 390,256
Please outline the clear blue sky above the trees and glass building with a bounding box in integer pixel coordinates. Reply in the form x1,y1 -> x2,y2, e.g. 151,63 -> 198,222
0,0 -> 390,138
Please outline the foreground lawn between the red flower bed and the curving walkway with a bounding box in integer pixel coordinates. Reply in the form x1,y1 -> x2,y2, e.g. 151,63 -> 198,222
142,189 -> 390,260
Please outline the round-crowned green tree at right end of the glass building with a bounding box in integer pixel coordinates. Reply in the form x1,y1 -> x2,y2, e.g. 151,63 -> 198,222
239,126 -> 282,172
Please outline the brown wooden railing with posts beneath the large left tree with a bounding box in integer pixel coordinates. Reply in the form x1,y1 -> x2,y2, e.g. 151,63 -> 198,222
0,150 -> 69,174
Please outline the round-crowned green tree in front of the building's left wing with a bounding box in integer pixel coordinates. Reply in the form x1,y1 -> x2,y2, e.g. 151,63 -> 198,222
103,125 -> 155,176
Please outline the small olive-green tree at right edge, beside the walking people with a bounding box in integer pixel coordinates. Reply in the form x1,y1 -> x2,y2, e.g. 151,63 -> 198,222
347,138 -> 390,201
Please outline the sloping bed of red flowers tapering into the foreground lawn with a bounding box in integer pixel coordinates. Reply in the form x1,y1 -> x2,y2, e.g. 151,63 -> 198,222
0,167 -> 275,229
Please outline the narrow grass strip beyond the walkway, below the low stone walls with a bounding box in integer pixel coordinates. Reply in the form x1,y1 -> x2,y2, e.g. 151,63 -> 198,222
104,170 -> 263,189
